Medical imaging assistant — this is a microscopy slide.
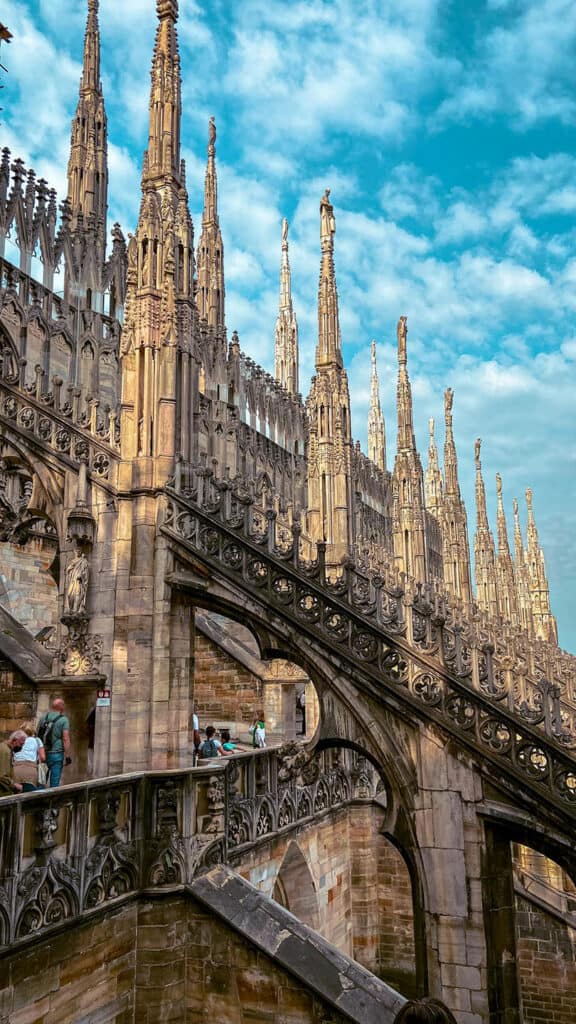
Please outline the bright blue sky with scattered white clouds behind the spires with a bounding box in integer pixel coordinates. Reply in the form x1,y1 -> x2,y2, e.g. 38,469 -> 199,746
0,0 -> 576,650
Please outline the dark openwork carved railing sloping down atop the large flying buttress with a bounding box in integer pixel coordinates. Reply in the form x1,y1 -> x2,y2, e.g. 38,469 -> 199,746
163,483 -> 576,816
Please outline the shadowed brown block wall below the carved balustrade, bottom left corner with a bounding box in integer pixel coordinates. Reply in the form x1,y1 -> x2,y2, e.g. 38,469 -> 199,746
0,896 -> 347,1024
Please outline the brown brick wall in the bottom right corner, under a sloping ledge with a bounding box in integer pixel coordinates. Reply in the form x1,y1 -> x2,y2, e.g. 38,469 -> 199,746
516,895 -> 576,1024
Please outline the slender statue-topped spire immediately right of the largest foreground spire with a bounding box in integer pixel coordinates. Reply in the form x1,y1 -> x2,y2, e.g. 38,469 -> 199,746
197,118 -> 224,328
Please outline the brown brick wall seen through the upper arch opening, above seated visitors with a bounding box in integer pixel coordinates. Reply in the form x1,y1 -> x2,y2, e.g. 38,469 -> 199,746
194,631 -> 263,727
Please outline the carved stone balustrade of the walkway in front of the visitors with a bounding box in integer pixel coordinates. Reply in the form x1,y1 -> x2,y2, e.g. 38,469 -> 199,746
0,743 -> 377,949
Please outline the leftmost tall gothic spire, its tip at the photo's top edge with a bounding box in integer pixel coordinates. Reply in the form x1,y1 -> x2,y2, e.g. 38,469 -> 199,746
68,0 -> 108,274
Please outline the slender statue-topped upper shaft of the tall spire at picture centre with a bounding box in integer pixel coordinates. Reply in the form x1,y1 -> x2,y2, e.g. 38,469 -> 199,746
316,188 -> 342,370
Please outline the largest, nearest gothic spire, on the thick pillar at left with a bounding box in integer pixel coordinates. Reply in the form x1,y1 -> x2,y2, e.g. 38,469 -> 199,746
120,0 -> 198,473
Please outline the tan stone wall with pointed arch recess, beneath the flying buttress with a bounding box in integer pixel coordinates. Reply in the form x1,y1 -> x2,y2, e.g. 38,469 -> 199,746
237,806 -> 416,994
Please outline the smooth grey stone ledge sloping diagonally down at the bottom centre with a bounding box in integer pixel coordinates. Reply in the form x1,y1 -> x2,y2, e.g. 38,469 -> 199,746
188,866 -> 405,1024
